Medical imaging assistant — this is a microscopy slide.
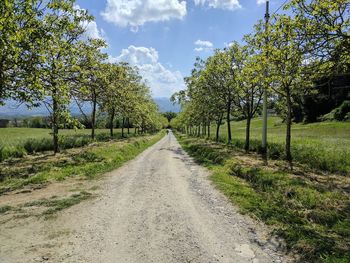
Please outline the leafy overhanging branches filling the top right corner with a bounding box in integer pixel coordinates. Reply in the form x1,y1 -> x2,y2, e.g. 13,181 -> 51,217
285,0 -> 350,74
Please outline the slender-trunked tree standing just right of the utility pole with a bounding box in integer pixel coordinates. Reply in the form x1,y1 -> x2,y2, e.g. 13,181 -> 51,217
268,15 -> 310,163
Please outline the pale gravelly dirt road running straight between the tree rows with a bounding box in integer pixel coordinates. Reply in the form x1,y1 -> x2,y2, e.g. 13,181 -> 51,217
0,134 -> 287,263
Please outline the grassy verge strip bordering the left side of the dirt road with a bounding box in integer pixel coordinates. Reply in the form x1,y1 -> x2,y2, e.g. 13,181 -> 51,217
0,132 -> 164,194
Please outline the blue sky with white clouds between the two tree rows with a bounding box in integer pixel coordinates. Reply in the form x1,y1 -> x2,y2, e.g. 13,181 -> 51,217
76,0 -> 284,97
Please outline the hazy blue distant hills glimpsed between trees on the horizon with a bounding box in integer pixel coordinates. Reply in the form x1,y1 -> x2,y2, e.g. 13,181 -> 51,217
0,98 -> 180,119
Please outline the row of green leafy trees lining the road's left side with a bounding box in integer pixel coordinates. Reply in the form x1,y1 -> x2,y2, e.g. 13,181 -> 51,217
0,0 -> 165,152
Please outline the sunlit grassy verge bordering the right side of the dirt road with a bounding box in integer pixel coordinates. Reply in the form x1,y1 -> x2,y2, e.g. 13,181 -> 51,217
177,135 -> 350,263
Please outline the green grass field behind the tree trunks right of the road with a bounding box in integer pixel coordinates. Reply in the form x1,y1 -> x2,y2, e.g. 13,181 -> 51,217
205,117 -> 350,175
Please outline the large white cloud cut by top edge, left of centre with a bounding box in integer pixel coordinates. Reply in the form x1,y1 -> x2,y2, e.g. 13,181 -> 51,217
102,0 -> 187,29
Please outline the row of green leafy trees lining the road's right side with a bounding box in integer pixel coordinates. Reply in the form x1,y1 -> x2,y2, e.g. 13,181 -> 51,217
172,0 -> 350,165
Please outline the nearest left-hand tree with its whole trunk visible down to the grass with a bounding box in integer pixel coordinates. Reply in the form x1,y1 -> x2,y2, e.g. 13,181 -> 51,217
37,0 -> 92,153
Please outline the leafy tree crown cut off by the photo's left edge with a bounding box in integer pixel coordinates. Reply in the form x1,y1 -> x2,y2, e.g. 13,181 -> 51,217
0,0 -> 47,106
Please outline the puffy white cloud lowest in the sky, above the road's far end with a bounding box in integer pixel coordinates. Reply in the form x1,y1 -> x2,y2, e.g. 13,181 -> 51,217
109,46 -> 185,97
